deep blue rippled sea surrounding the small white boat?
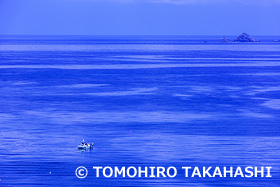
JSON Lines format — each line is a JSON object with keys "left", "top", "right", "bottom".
{"left": 0, "top": 36, "right": 280, "bottom": 187}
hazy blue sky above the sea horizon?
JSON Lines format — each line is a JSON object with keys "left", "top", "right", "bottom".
{"left": 0, "top": 0, "right": 280, "bottom": 35}
